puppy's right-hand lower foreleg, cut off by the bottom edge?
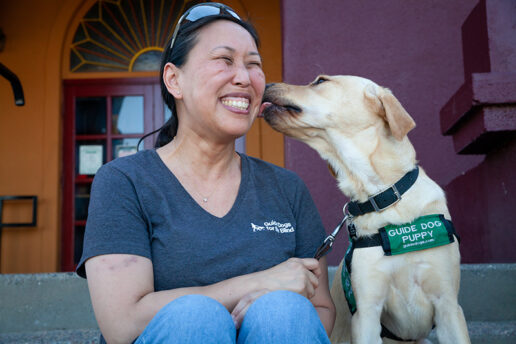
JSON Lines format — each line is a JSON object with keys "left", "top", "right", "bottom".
{"left": 435, "top": 298, "right": 470, "bottom": 344}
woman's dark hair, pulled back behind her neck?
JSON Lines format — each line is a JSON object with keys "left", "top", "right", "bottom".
{"left": 138, "top": 9, "right": 260, "bottom": 148}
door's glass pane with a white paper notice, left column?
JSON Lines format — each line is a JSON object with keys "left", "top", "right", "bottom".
{"left": 75, "top": 140, "right": 106, "bottom": 178}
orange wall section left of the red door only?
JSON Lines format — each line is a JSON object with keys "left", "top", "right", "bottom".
{"left": 0, "top": 0, "right": 80, "bottom": 273}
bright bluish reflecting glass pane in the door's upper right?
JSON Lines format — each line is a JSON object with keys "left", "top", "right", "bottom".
{"left": 111, "top": 96, "right": 143, "bottom": 134}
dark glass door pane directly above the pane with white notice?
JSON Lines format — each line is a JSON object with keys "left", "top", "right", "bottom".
{"left": 75, "top": 97, "right": 107, "bottom": 135}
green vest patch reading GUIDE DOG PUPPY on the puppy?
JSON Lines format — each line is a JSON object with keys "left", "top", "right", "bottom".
{"left": 379, "top": 215, "right": 456, "bottom": 256}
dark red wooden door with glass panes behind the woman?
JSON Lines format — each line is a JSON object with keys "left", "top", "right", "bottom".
{"left": 61, "top": 78, "right": 166, "bottom": 271}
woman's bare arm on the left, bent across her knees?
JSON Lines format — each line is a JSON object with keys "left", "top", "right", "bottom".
{"left": 86, "top": 254, "right": 318, "bottom": 343}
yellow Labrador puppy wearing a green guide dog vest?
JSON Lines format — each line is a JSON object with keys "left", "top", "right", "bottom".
{"left": 263, "top": 75, "right": 470, "bottom": 344}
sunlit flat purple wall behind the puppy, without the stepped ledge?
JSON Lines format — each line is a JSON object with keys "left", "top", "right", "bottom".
{"left": 282, "top": 0, "right": 483, "bottom": 265}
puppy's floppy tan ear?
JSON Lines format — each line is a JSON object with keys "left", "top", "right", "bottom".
{"left": 365, "top": 84, "right": 416, "bottom": 141}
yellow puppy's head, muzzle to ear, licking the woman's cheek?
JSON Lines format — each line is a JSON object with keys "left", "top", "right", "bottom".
{"left": 263, "top": 75, "right": 415, "bottom": 141}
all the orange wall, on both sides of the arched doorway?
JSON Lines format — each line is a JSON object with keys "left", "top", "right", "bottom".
{"left": 0, "top": 0, "right": 284, "bottom": 273}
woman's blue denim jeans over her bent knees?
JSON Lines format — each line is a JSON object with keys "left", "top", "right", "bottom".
{"left": 135, "top": 291, "right": 330, "bottom": 344}
